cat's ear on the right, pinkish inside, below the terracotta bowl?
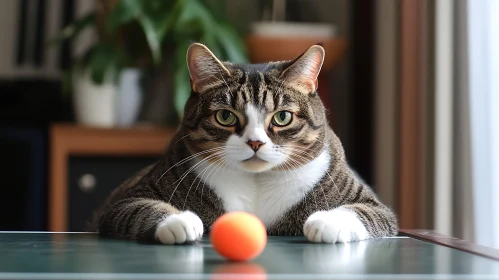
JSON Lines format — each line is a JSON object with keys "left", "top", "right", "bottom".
{"left": 281, "top": 45, "right": 325, "bottom": 94}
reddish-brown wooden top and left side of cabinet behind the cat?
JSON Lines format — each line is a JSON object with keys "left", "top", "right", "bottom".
{"left": 49, "top": 123, "right": 176, "bottom": 231}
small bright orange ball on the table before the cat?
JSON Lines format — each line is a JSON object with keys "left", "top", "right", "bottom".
{"left": 210, "top": 212, "right": 267, "bottom": 261}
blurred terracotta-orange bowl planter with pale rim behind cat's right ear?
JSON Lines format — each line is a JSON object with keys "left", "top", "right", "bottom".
{"left": 245, "top": 0, "right": 347, "bottom": 123}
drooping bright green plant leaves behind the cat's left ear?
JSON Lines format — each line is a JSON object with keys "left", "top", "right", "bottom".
{"left": 103, "top": 0, "right": 248, "bottom": 120}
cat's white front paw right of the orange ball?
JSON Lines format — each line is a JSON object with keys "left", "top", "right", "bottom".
{"left": 303, "top": 208, "right": 369, "bottom": 243}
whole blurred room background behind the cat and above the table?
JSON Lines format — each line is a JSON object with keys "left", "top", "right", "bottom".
{"left": 0, "top": 0, "right": 499, "bottom": 248}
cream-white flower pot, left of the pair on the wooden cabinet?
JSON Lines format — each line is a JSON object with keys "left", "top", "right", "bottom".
{"left": 73, "top": 72, "right": 117, "bottom": 127}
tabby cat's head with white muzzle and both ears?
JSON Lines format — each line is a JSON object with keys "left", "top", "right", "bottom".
{"left": 183, "top": 43, "right": 328, "bottom": 172}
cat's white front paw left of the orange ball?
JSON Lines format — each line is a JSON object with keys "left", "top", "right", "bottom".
{"left": 154, "top": 211, "right": 204, "bottom": 245}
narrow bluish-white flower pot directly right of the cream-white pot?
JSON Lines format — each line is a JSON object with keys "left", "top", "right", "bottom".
{"left": 116, "top": 68, "right": 142, "bottom": 126}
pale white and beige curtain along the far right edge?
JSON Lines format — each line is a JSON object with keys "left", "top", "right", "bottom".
{"left": 433, "top": 0, "right": 499, "bottom": 248}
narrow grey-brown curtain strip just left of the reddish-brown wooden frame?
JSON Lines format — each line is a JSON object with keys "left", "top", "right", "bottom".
{"left": 374, "top": 1, "right": 399, "bottom": 209}
